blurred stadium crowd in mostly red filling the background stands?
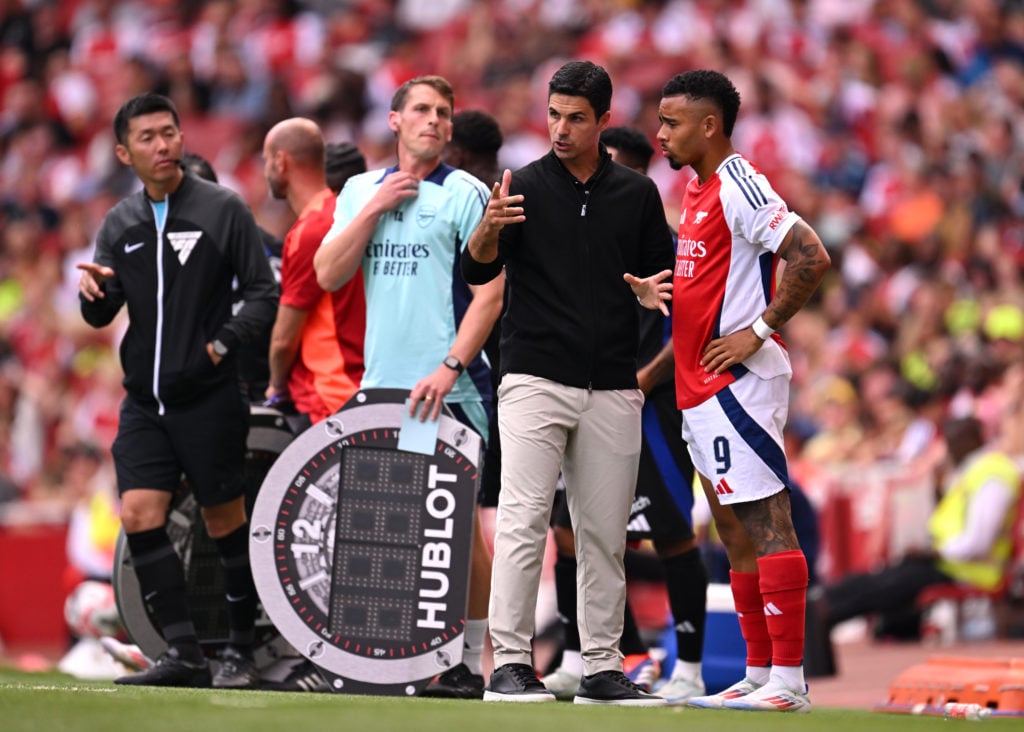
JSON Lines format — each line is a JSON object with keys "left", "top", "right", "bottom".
{"left": 0, "top": 0, "right": 1024, "bottom": 593}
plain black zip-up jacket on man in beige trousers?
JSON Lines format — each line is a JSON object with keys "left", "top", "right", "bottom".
{"left": 462, "top": 145, "right": 675, "bottom": 389}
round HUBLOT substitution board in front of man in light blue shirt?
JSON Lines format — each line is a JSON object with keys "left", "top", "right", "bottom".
{"left": 249, "top": 389, "right": 482, "bottom": 696}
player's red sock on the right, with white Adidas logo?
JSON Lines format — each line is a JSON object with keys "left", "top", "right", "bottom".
{"left": 758, "top": 549, "right": 807, "bottom": 665}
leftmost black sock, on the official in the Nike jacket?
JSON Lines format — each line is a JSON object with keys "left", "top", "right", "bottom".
{"left": 125, "top": 526, "right": 203, "bottom": 662}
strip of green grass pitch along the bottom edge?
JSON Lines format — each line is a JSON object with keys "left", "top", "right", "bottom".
{"left": 0, "top": 669, "right": 1024, "bottom": 732}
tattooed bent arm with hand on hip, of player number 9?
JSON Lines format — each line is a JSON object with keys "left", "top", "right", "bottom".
{"left": 700, "top": 221, "right": 831, "bottom": 374}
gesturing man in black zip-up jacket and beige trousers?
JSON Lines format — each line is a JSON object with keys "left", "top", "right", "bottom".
{"left": 462, "top": 61, "right": 673, "bottom": 705}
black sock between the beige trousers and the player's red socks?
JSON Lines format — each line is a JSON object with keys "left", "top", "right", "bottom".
{"left": 662, "top": 549, "right": 708, "bottom": 663}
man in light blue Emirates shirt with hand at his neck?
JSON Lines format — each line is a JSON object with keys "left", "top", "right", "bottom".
{"left": 313, "top": 76, "right": 504, "bottom": 698}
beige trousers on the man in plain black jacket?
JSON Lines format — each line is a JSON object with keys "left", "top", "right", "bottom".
{"left": 488, "top": 374, "right": 643, "bottom": 676}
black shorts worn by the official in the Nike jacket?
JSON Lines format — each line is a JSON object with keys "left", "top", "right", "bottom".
{"left": 111, "top": 382, "right": 249, "bottom": 507}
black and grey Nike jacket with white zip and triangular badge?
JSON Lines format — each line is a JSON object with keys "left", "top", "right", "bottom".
{"left": 79, "top": 173, "right": 278, "bottom": 413}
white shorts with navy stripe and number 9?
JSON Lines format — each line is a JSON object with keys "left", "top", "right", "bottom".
{"left": 683, "top": 373, "right": 790, "bottom": 505}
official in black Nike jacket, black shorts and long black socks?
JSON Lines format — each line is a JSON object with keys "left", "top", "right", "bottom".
{"left": 79, "top": 94, "right": 278, "bottom": 688}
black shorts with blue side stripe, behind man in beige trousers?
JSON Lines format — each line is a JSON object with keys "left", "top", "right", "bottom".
{"left": 551, "top": 387, "right": 693, "bottom": 542}
